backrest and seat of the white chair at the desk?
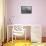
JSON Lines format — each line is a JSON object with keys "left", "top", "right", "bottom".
{"left": 12, "top": 25, "right": 24, "bottom": 36}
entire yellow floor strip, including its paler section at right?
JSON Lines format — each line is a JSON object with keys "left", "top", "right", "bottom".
{"left": 3, "top": 40, "right": 46, "bottom": 46}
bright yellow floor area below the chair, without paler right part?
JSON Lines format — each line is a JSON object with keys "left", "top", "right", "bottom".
{"left": 4, "top": 40, "right": 31, "bottom": 46}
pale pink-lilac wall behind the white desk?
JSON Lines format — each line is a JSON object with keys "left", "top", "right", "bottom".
{"left": 7, "top": 0, "right": 46, "bottom": 37}
